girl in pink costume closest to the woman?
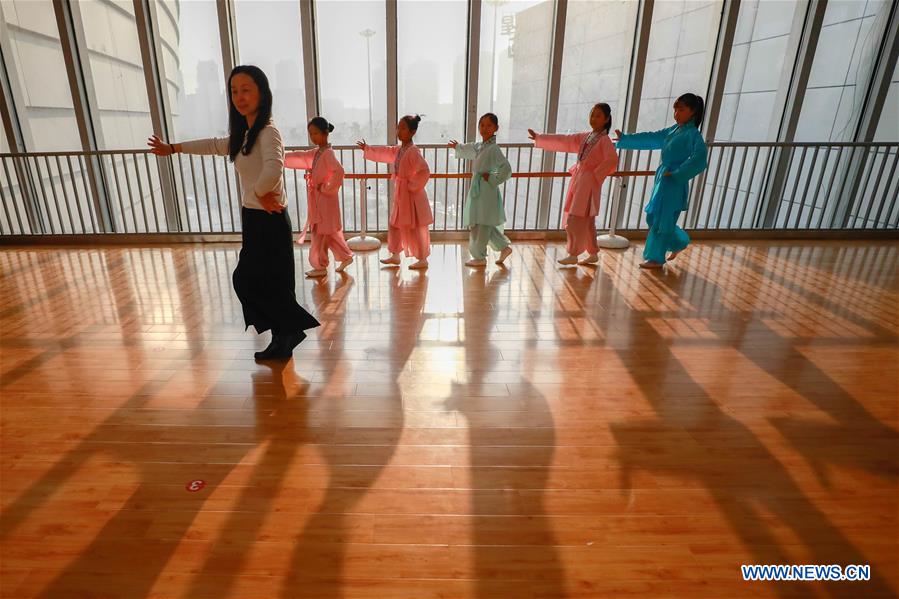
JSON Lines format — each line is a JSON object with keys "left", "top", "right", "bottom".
{"left": 284, "top": 116, "right": 353, "bottom": 277}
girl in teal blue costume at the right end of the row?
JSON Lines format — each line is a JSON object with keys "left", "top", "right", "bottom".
{"left": 615, "top": 94, "right": 708, "bottom": 268}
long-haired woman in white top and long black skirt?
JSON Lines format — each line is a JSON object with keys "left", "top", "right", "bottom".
{"left": 149, "top": 66, "right": 319, "bottom": 360}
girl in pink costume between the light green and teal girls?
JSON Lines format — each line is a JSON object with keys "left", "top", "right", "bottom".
{"left": 528, "top": 103, "right": 618, "bottom": 265}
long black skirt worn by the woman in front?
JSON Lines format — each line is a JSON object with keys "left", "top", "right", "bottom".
{"left": 232, "top": 208, "right": 320, "bottom": 334}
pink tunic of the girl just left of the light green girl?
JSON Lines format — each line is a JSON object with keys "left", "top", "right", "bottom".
{"left": 364, "top": 145, "right": 434, "bottom": 229}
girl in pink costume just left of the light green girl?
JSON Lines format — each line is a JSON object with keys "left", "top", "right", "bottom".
{"left": 357, "top": 115, "right": 434, "bottom": 269}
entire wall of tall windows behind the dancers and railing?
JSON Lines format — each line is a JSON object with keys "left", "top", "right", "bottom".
{"left": 0, "top": 0, "right": 899, "bottom": 233}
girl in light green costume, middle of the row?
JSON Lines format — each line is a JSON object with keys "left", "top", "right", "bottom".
{"left": 448, "top": 112, "right": 512, "bottom": 267}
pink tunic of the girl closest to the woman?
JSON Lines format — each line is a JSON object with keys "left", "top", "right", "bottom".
{"left": 284, "top": 148, "right": 343, "bottom": 243}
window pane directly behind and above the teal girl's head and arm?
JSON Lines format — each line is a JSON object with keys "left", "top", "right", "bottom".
{"left": 638, "top": 0, "right": 722, "bottom": 131}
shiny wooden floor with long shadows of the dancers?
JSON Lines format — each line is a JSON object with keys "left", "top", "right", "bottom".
{"left": 0, "top": 242, "right": 899, "bottom": 599}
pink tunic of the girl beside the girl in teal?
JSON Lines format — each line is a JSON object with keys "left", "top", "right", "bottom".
{"left": 534, "top": 131, "right": 618, "bottom": 224}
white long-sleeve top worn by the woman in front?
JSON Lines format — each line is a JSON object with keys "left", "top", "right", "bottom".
{"left": 181, "top": 122, "right": 287, "bottom": 210}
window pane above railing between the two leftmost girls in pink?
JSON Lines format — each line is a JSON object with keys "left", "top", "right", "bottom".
{"left": 315, "top": 0, "right": 386, "bottom": 144}
